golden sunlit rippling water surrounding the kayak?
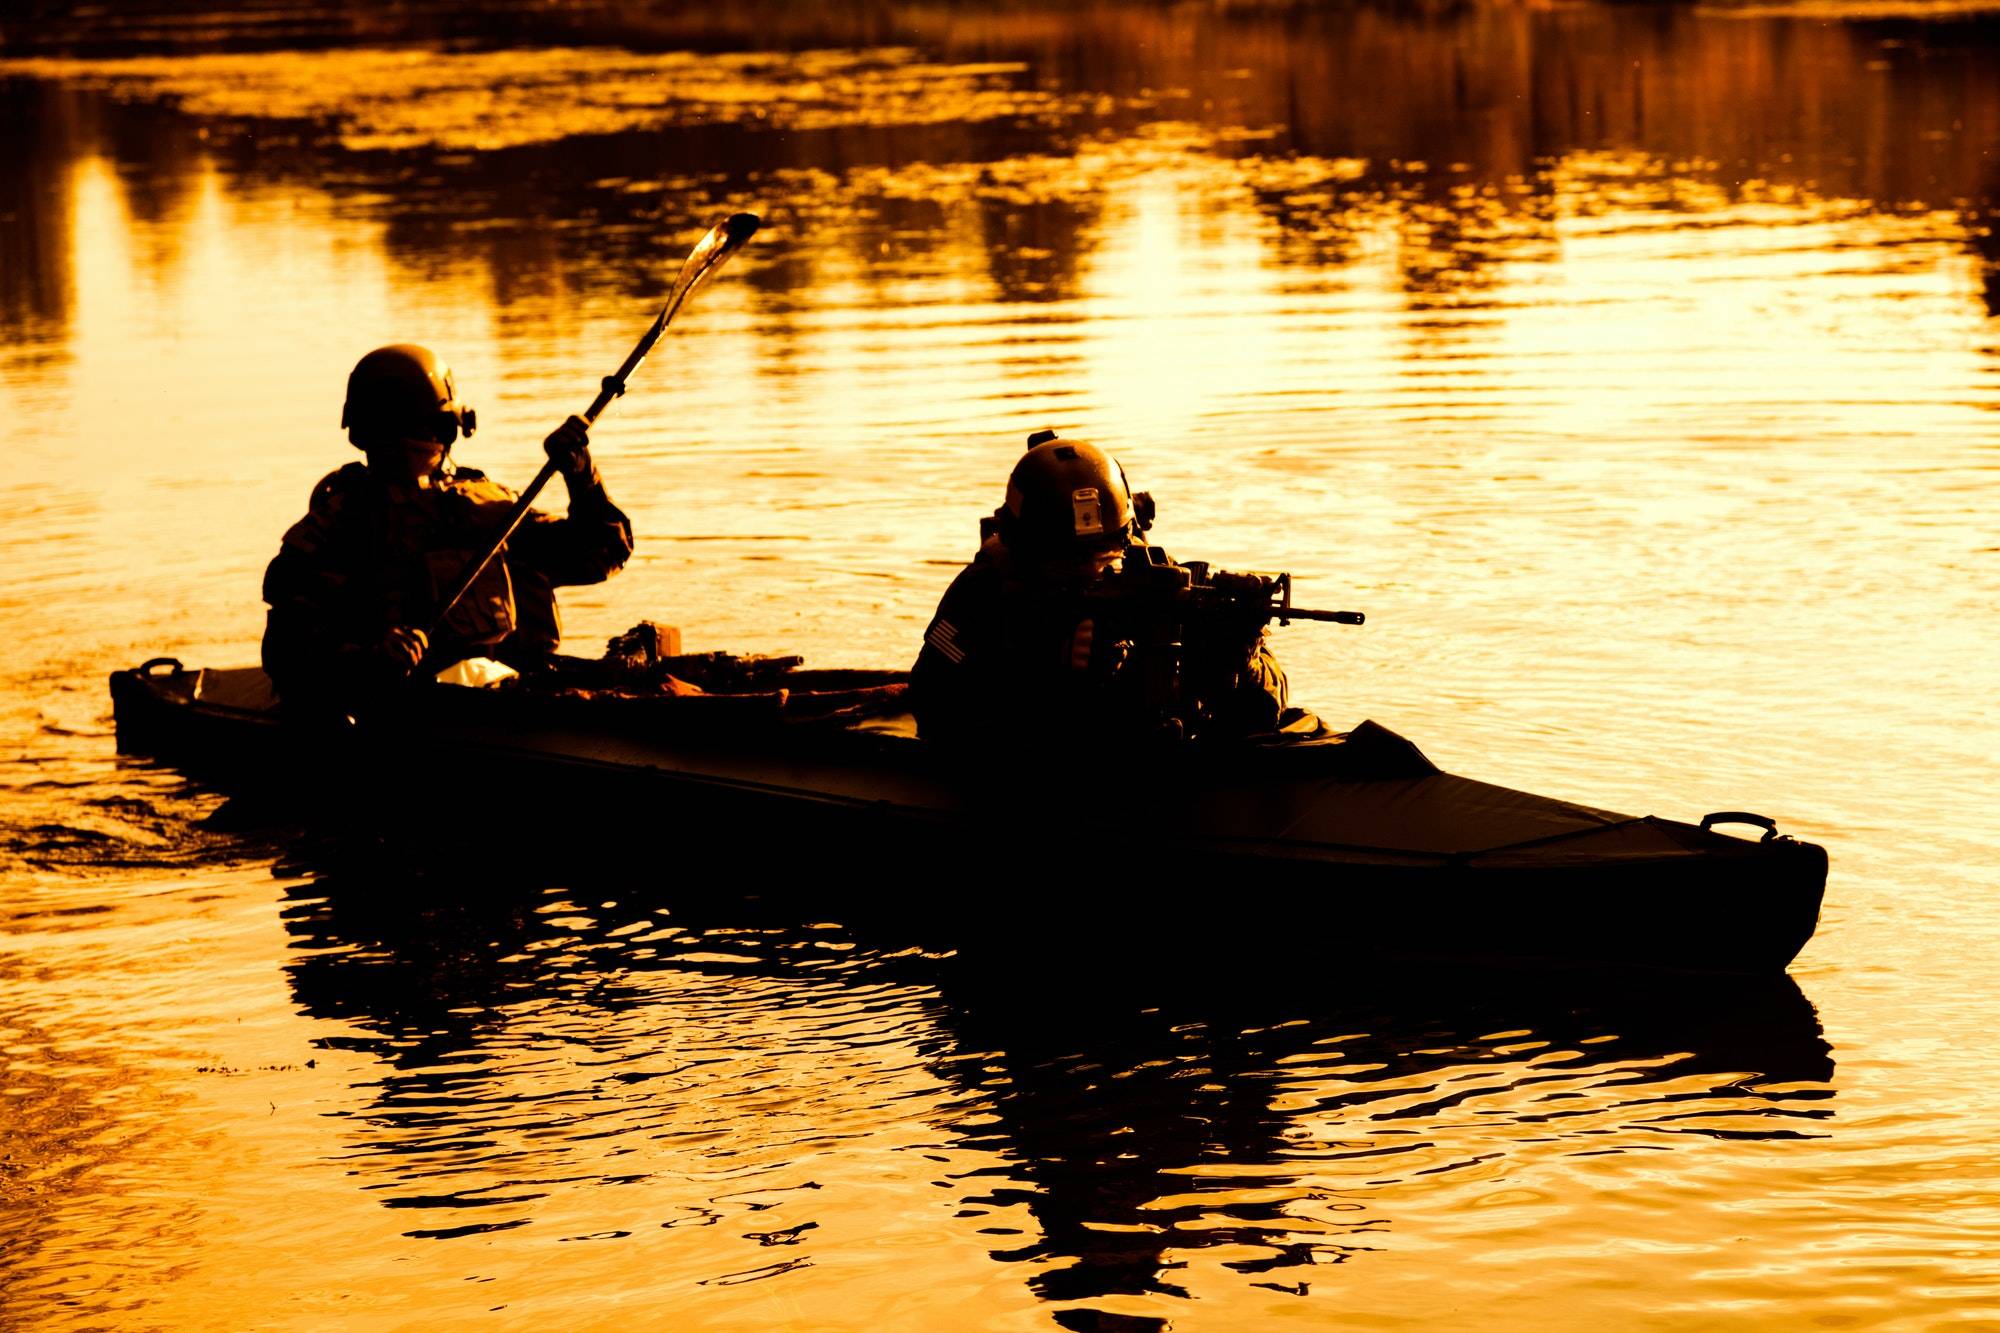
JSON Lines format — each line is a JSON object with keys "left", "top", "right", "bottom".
{"left": 0, "top": 4, "right": 2000, "bottom": 1329}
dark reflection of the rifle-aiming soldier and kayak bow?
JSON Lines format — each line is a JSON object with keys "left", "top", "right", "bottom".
{"left": 946, "top": 959, "right": 1832, "bottom": 1301}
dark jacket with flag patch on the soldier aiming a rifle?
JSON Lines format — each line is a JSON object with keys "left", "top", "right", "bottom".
{"left": 910, "top": 542, "right": 1318, "bottom": 748}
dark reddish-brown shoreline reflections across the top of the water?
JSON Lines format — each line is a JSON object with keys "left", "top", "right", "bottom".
{"left": 0, "top": 0, "right": 2000, "bottom": 378}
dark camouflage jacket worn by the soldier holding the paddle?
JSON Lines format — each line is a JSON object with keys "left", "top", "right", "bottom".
{"left": 264, "top": 462, "right": 632, "bottom": 701}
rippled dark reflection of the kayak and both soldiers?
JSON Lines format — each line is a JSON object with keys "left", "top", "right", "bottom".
{"left": 266, "top": 856, "right": 1834, "bottom": 1327}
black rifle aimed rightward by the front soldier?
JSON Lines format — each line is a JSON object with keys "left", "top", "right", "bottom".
{"left": 1078, "top": 542, "right": 1366, "bottom": 737}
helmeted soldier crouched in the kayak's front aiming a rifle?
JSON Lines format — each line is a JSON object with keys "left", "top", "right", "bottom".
{"left": 910, "top": 430, "right": 1320, "bottom": 755}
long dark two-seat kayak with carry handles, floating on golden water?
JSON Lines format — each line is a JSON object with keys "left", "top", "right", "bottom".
{"left": 110, "top": 654, "right": 1828, "bottom": 975}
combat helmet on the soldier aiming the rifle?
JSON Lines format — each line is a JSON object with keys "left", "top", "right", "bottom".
{"left": 992, "top": 430, "right": 1152, "bottom": 556}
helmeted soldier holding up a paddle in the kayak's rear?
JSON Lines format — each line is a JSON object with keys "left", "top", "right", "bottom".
{"left": 264, "top": 344, "right": 632, "bottom": 711}
